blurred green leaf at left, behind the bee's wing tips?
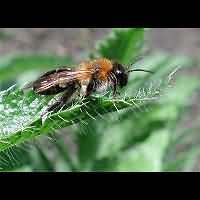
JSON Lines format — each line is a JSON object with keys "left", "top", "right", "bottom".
{"left": 0, "top": 54, "right": 72, "bottom": 87}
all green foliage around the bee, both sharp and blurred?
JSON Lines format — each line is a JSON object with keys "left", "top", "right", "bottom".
{"left": 0, "top": 28, "right": 200, "bottom": 171}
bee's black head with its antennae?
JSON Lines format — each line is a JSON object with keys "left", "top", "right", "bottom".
{"left": 112, "top": 62, "right": 153, "bottom": 88}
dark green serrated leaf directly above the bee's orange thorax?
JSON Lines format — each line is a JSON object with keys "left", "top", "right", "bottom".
{"left": 93, "top": 28, "right": 144, "bottom": 64}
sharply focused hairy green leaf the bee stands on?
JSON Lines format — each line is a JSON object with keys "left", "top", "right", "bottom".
{"left": 0, "top": 84, "right": 156, "bottom": 151}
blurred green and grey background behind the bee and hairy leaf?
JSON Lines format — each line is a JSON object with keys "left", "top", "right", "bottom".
{"left": 0, "top": 28, "right": 200, "bottom": 172}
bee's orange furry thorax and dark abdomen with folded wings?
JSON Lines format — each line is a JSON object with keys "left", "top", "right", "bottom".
{"left": 33, "top": 59, "right": 123, "bottom": 96}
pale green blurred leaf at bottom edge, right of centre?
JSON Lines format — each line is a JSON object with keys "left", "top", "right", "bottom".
{"left": 94, "top": 130, "right": 169, "bottom": 172}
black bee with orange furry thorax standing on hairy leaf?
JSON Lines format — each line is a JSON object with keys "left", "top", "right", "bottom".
{"left": 25, "top": 58, "right": 152, "bottom": 112}
